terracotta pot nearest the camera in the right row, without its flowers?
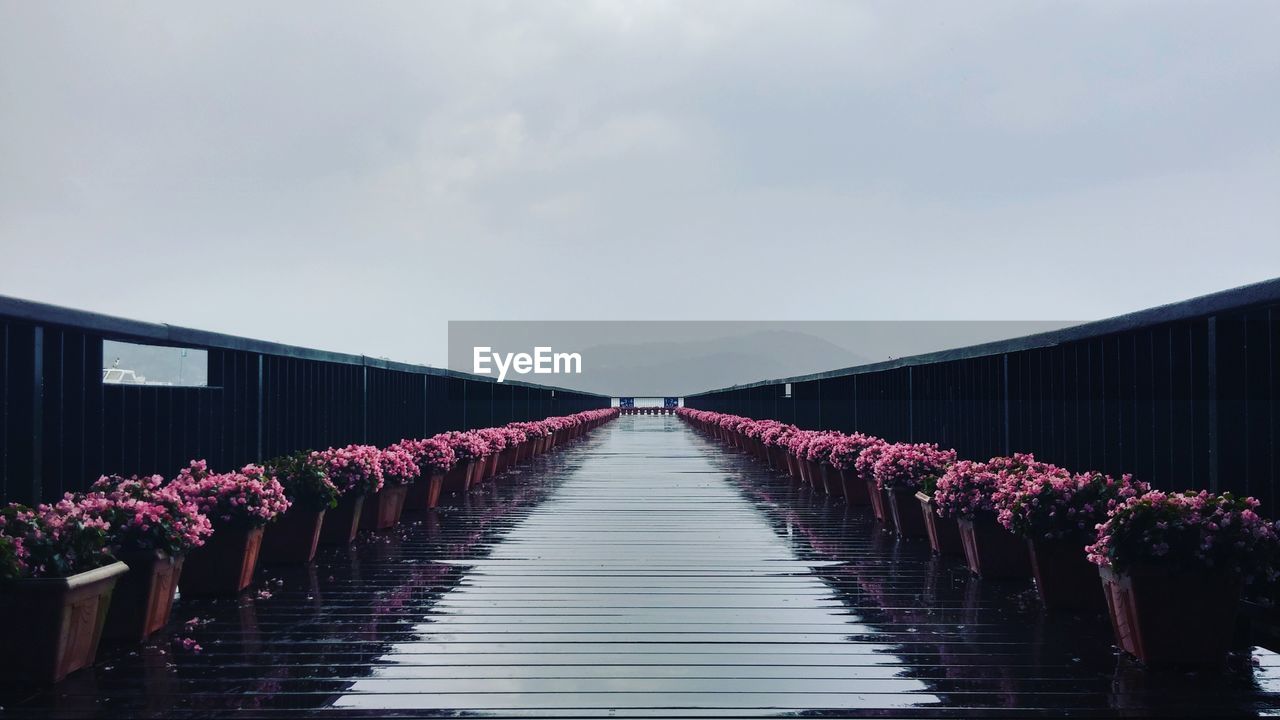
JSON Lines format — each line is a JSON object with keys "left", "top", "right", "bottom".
{"left": 1098, "top": 568, "right": 1242, "bottom": 665}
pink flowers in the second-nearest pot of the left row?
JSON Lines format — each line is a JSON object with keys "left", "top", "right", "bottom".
{"left": 79, "top": 475, "right": 214, "bottom": 557}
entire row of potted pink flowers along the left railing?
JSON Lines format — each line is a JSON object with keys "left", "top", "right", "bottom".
{"left": 0, "top": 410, "right": 617, "bottom": 682}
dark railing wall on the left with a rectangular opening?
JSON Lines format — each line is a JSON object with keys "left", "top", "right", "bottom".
{"left": 0, "top": 296, "right": 609, "bottom": 502}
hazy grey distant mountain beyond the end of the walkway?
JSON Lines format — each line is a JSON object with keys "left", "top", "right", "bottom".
{"left": 556, "top": 331, "right": 868, "bottom": 397}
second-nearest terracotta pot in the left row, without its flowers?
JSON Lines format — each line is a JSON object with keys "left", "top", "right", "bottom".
{"left": 102, "top": 550, "right": 184, "bottom": 642}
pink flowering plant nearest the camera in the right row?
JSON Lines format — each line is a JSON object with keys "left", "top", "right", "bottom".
{"left": 1084, "top": 491, "right": 1280, "bottom": 583}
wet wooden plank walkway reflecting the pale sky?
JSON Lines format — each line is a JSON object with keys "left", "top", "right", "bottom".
{"left": 0, "top": 416, "right": 1280, "bottom": 719}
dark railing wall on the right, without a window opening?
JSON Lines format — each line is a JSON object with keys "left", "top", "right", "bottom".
{"left": 685, "top": 279, "right": 1280, "bottom": 515}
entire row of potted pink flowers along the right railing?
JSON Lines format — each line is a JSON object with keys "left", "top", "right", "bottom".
{"left": 680, "top": 409, "right": 1280, "bottom": 664}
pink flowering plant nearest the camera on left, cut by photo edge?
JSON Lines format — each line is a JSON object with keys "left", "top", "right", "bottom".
{"left": 0, "top": 493, "right": 115, "bottom": 579}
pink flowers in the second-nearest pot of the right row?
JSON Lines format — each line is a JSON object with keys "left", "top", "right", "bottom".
{"left": 995, "top": 464, "right": 1151, "bottom": 544}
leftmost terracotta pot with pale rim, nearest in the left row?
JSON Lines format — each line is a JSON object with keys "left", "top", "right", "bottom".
{"left": 0, "top": 562, "right": 129, "bottom": 683}
